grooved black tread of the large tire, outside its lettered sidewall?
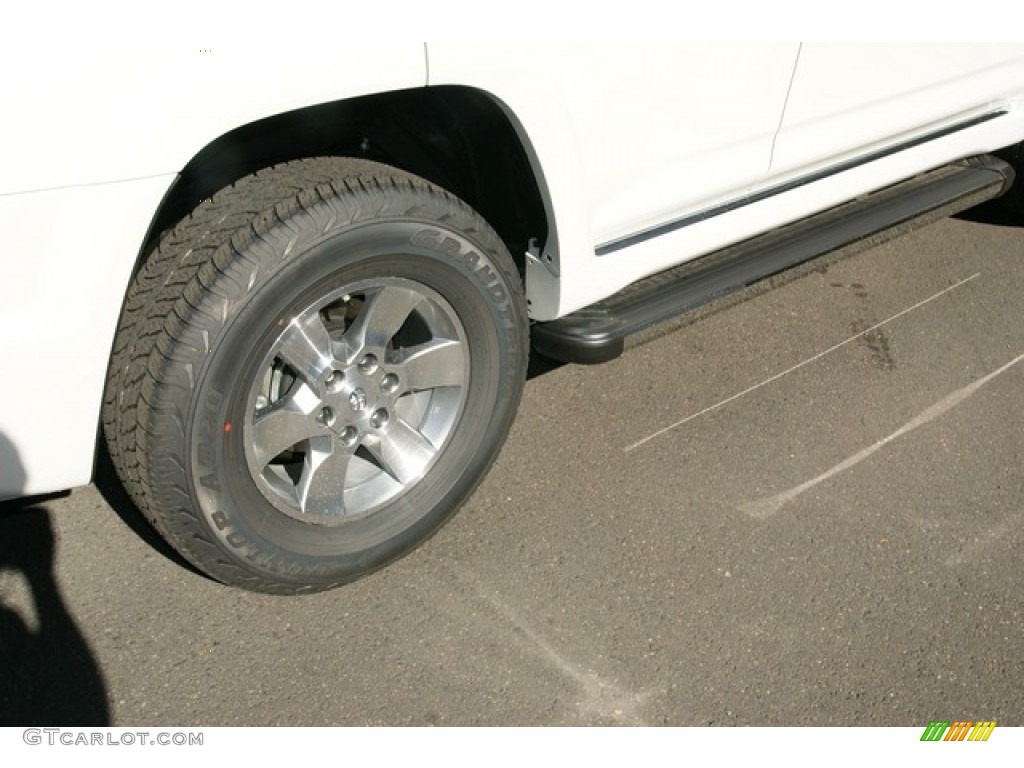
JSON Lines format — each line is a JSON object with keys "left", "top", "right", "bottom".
{"left": 101, "top": 157, "right": 526, "bottom": 594}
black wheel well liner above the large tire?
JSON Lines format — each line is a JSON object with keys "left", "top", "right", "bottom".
{"left": 142, "top": 86, "right": 549, "bottom": 272}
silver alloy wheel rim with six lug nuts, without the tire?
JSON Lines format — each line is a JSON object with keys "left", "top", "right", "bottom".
{"left": 246, "top": 275, "right": 470, "bottom": 524}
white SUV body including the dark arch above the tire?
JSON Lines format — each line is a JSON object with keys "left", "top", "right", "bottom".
{"left": 0, "top": 44, "right": 1024, "bottom": 588}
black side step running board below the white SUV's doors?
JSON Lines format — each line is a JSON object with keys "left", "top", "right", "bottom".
{"left": 532, "top": 155, "right": 1014, "bottom": 364}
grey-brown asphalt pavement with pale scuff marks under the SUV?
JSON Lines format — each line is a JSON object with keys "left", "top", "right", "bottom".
{"left": 0, "top": 205, "right": 1024, "bottom": 728}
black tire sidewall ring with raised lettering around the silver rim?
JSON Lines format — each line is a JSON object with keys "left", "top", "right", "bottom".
{"left": 185, "top": 214, "right": 525, "bottom": 585}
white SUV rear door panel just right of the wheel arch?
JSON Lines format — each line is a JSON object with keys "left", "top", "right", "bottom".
{"left": 428, "top": 43, "right": 798, "bottom": 246}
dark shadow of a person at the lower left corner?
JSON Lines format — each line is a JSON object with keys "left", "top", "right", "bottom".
{"left": 0, "top": 434, "right": 111, "bottom": 726}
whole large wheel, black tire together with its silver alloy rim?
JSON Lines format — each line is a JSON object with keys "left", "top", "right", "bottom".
{"left": 103, "top": 158, "right": 528, "bottom": 594}
